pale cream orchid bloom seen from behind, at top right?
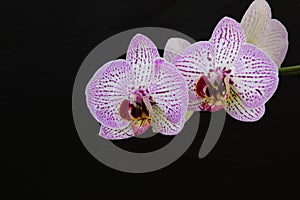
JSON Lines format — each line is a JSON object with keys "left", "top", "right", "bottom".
{"left": 241, "top": 0, "right": 288, "bottom": 67}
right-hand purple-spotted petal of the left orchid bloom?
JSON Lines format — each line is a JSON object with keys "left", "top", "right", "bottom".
{"left": 148, "top": 59, "right": 188, "bottom": 123}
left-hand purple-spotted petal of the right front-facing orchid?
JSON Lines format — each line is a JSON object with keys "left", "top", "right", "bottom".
{"left": 173, "top": 41, "right": 214, "bottom": 111}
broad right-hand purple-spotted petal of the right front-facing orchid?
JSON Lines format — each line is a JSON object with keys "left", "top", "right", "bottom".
{"left": 231, "top": 44, "right": 278, "bottom": 108}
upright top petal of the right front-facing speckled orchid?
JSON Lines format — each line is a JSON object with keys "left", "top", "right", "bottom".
{"left": 210, "top": 17, "right": 246, "bottom": 71}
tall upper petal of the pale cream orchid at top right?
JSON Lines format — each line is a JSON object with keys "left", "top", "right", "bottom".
{"left": 241, "top": 0, "right": 271, "bottom": 45}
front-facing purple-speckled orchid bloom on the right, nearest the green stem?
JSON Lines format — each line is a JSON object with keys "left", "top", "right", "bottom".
{"left": 172, "top": 17, "right": 278, "bottom": 121}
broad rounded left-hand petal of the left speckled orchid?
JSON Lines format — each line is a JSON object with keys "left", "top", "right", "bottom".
{"left": 86, "top": 60, "right": 133, "bottom": 128}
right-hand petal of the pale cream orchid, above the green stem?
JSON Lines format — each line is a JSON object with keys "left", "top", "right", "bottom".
{"left": 256, "top": 19, "right": 289, "bottom": 67}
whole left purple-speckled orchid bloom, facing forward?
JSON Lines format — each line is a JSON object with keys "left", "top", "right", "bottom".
{"left": 86, "top": 34, "right": 188, "bottom": 140}
